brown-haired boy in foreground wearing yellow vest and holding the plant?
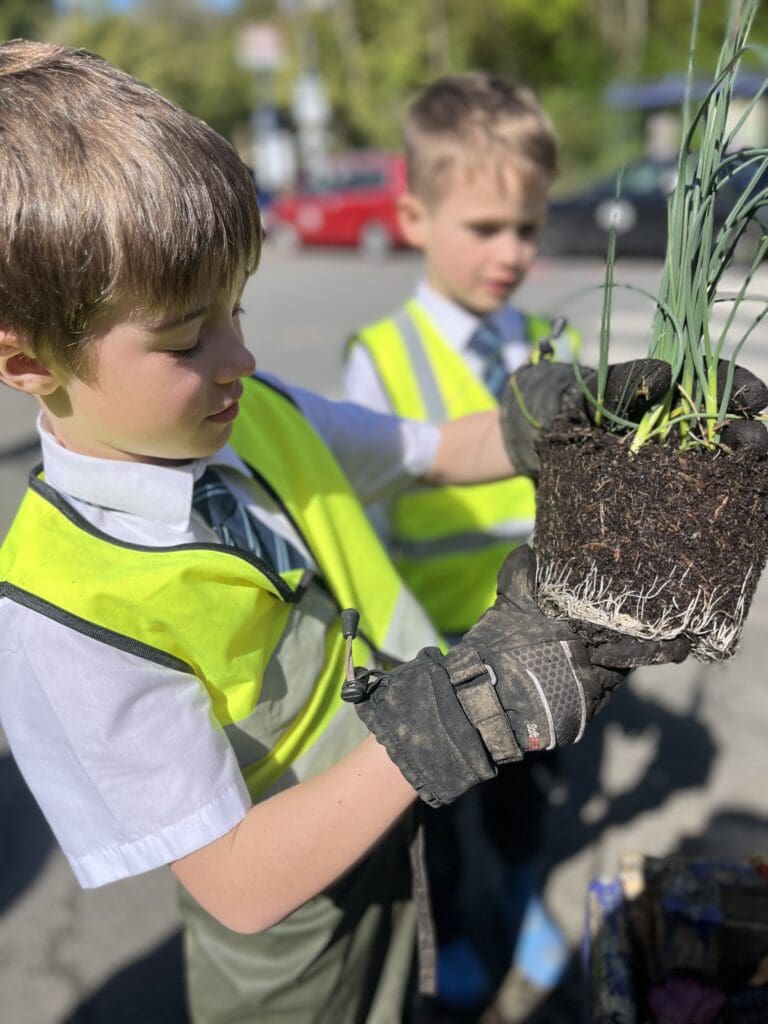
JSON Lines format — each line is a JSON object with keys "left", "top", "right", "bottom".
{"left": 0, "top": 41, "right": 685, "bottom": 1024}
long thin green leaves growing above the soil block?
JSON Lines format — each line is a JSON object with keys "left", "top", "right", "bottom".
{"left": 589, "top": 0, "right": 768, "bottom": 450}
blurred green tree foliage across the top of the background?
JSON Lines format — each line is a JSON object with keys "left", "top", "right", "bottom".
{"left": 40, "top": 0, "right": 768, "bottom": 182}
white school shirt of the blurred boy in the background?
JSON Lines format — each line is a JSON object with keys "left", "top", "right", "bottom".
{"left": 344, "top": 281, "right": 530, "bottom": 413}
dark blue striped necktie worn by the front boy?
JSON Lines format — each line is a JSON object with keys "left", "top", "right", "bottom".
{"left": 193, "top": 467, "right": 307, "bottom": 572}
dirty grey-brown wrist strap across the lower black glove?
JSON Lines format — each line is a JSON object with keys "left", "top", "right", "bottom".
{"left": 442, "top": 643, "right": 523, "bottom": 764}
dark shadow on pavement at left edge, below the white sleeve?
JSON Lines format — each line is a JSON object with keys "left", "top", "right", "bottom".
{"left": 0, "top": 754, "right": 54, "bottom": 913}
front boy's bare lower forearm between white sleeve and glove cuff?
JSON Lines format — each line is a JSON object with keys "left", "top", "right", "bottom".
{"left": 172, "top": 737, "right": 416, "bottom": 933}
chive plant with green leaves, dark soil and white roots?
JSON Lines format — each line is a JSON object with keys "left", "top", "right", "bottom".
{"left": 535, "top": 0, "right": 768, "bottom": 662}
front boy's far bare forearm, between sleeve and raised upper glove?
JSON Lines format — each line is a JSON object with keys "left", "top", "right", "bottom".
{"left": 423, "top": 410, "right": 515, "bottom": 484}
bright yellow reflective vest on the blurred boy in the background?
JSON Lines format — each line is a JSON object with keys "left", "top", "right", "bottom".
{"left": 347, "top": 300, "right": 580, "bottom": 635}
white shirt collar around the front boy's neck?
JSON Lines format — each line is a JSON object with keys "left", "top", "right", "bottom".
{"left": 38, "top": 414, "right": 244, "bottom": 529}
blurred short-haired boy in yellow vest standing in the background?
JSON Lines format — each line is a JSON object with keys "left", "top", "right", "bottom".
{"left": 345, "top": 73, "right": 578, "bottom": 637}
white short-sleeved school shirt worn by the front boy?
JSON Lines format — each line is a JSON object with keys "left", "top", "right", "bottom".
{"left": 0, "top": 376, "right": 439, "bottom": 888}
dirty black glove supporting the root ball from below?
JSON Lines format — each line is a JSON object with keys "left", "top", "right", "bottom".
{"left": 344, "top": 546, "right": 688, "bottom": 807}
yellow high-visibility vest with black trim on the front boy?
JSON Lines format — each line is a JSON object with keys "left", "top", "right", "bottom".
{"left": 0, "top": 379, "right": 437, "bottom": 798}
